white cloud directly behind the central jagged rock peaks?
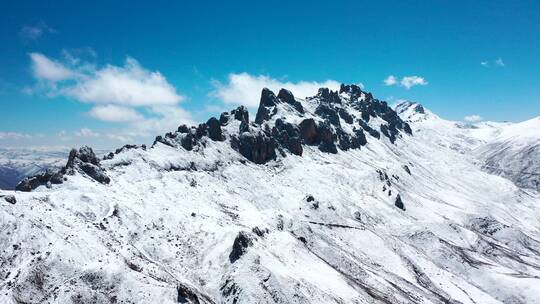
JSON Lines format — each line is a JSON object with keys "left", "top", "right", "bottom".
{"left": 211, "top": 73, "right": 340, "bottom": 107}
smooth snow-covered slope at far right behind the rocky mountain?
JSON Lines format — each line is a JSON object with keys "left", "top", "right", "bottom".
{"left": 396, "top": 102, "right": 540, "bottom": 190}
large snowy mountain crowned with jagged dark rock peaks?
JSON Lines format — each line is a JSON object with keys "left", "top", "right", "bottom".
{"left": 0, "top": 85, "right": 540, "bottom": 303}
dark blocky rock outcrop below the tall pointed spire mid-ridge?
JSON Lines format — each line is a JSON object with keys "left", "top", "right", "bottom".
{"left": 231, "top": 131, "right": 276, "bottom": 164}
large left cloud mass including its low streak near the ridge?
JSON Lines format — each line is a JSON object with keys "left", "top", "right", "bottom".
{"left": 26, "top": 49, "right": 193, "bottom": 140}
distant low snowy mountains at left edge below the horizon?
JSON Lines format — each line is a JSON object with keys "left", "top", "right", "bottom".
{"left": 0, "top": 148, "right": 69, "bottom": 190}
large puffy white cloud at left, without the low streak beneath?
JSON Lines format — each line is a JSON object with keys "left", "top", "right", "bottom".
{"left": 30, "top": 53, "right": 184, "bottom": 106}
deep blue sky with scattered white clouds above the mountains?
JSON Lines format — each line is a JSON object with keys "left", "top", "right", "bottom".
{"left": 0, "top": 1, "right": 540, "bottom": 148}
